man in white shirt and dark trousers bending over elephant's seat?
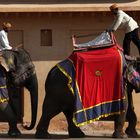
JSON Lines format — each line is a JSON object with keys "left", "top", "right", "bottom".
{"left": 108, "top": 4, "right": 140, "bottom": 55}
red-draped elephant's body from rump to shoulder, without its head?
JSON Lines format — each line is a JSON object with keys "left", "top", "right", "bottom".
{"left": 35, "top": 32, "right": 127, "bottom": 138}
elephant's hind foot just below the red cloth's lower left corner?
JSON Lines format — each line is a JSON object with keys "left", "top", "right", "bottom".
{"left": 68, "top": 127, "right": 85, "bottom": 138}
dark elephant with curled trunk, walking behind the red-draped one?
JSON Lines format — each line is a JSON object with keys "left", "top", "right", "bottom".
{"left": 0, "top": 48, "right": 38, "bottom": 137}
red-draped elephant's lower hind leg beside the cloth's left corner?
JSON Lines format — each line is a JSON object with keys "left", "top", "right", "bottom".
{"left": 63, "top": 110, "right": 85, "bottom": 138}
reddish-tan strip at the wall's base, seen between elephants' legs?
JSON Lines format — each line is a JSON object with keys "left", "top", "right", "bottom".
{"left": 0, "top": 118, "right": 140, "bottom": 135}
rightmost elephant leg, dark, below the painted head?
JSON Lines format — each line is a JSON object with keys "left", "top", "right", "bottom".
{"left": 125, "top": 84, "right": 138, "bottom": 138}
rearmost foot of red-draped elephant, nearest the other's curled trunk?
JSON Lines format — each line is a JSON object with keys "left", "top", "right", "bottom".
{"left": 35, "top": 129, "right": 51, "bottom": 139}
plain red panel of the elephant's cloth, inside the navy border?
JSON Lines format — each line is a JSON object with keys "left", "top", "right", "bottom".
{"left": 70, "top": 47, "right": 122, "bottom": 108}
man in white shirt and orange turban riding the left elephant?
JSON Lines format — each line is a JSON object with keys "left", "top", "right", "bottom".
{"left": 0, "top": 22, "right": 12, "bottom": 51}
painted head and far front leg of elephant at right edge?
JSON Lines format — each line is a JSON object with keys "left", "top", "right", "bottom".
{"left": 125, "top": 55, "right": 140, "bottom": 138}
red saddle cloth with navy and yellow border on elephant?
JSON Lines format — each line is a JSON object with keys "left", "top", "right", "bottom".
{"left": 57, "top": 45, "right": 125, "bottom": 126}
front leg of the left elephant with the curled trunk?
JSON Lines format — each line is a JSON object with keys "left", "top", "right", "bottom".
{"left": 0, "top": 102, "right": 21, "bottom": 137}
